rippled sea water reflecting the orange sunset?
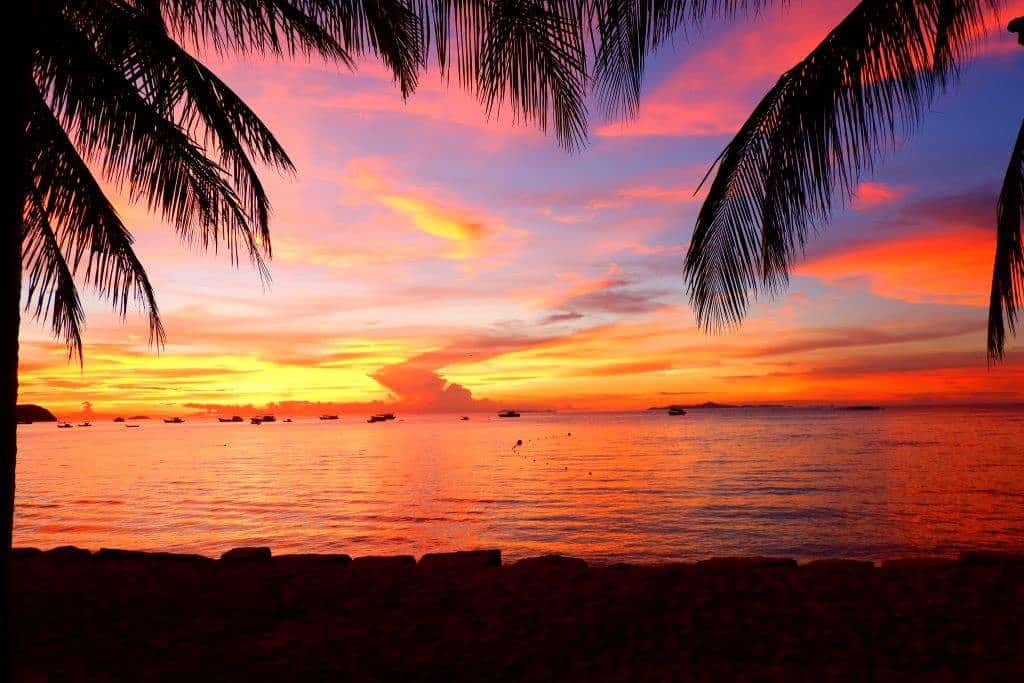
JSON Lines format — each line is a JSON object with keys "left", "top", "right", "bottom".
{"left": 14, "top": 408, "right": 1024, "bottom": 561}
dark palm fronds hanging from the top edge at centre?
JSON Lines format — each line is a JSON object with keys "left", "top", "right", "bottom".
{"left": 408, "top": 0, "right": 770, "bottom": 150}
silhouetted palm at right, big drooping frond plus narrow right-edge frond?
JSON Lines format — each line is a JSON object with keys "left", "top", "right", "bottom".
{"left": 684, "top": 0, "right": 1024, "bottom": 362}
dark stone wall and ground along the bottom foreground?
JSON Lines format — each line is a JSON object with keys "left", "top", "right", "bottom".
{"left": 12, "top": 549, "right": 1024, "bottom": 681}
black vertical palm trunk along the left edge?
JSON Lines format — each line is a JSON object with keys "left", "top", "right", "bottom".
{"left": 0, "top": 30, "right": 35, "bottom": 680}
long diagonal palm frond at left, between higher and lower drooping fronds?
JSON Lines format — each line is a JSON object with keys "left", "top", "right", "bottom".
{"left": 37, "top": 8, "right": 268, "bottom": 278}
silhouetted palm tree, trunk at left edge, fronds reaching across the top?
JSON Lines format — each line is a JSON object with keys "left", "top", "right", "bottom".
{"left": 0, "top": 0, "right": 774, "bottom": 663}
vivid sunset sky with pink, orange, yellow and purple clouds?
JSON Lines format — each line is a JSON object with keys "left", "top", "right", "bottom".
{"left": 20, "top": 0, "right": 1024, "bottom": 417}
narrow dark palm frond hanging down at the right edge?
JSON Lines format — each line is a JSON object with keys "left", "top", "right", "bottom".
{"left": 988, "top": 121, "right": 1024, "bottom": 362}
